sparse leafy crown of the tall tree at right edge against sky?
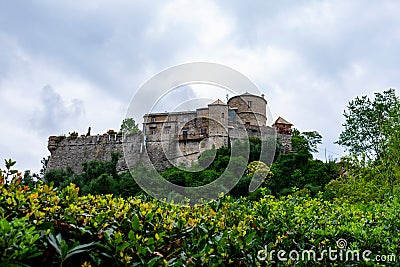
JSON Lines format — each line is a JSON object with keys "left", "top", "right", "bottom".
{"left": 336, "top": 89, "right": 400, "bottom": 160}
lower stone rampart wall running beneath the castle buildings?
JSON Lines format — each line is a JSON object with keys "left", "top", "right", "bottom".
{"left": 47, "top": 126, "right": 290, "bottom": 173}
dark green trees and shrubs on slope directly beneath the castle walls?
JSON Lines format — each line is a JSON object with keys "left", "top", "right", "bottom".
{"left": 44, "top": 129, "right": 339, "bottom": 198}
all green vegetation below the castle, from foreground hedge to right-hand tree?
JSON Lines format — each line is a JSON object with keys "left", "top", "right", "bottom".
{"left": 0, "top": 90, "right": 400, "bottom": 266}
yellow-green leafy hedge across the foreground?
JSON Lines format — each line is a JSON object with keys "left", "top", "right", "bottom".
{"left": 0, "top": 170, "right": 400, "bottom": 266}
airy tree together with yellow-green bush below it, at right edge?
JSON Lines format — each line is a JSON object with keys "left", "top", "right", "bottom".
{"left": 326, "top": 89, "right": 400, "bottom": 203}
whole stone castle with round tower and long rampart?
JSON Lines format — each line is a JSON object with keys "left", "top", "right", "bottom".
{"left": 48, "top": 93, "right": 292, "bottom": 172}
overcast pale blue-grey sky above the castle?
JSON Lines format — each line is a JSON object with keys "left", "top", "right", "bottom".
{"left": 0, "top": 0, "right": 400, "bottom": 171}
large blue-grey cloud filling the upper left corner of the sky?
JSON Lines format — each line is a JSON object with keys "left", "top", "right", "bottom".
{"left": 0, "top": 1, "right": 169, "bottom": 99}
